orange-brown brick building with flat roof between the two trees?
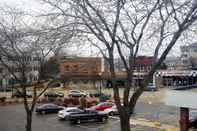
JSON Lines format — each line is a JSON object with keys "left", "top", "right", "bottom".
{"left": 59, "top": 57, "right": 103, "bottom": 87}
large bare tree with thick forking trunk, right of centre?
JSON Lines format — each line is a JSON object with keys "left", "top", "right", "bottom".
{"left": 40, "top": 0, "right": 197, "bottom": 131}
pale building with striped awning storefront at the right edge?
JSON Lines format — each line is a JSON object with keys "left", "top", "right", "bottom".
{"left": 154, "top": 42, "right": 197, "bottom": 88}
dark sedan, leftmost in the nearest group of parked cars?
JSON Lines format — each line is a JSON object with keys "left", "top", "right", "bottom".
{"left": 36, "top": 104, "right": 65, "bottom": 114}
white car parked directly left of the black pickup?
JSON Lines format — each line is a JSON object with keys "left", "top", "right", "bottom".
{"left": 58, "top": 107, "right": 83, "bottom": 120}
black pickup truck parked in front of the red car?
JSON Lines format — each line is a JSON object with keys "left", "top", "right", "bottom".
{"left": 69, "top": 110, "right": 108, "bottom": 124}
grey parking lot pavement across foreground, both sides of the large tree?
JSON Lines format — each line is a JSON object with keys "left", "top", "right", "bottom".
{"left": 0, "top": 103, "right": 182, "bottom": 131}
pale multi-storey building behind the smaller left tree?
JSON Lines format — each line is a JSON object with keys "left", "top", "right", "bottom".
{"left": 0, "top": 56, "right": 40, "bottom": 88}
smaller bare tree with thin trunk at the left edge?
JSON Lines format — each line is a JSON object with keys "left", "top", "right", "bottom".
{"left": 0, "top": 8, "right": 75, "bottom": 131}
